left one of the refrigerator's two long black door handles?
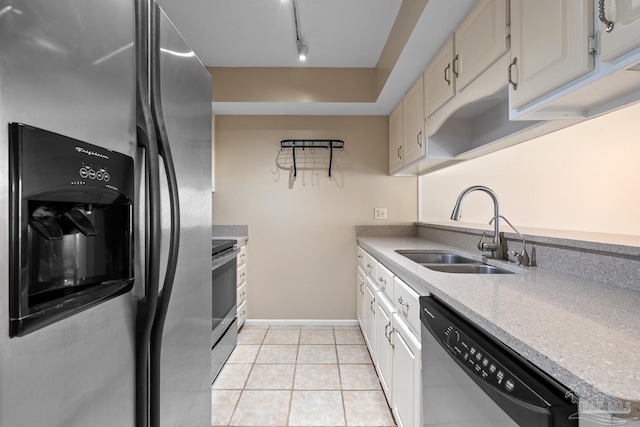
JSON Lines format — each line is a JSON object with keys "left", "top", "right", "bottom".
{"left": 135, "top": 0, "right": 161, "bottom": 427}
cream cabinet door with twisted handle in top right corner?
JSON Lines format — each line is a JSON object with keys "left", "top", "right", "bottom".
{"left": 598, "top": 0, "right": 640, "bottom": 61}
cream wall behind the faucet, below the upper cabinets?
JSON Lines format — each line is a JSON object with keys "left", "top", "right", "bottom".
{"left": 420, "top": 100, "right": 640, "bottom": 244}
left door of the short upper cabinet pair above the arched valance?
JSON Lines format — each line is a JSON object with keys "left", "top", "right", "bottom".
{"left": 424, "top": 36, "right": 456, "bottom": 117}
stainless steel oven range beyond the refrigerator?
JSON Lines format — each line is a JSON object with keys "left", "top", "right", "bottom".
{"left": 211, "top": 239, "right": 240, "bottom": 382}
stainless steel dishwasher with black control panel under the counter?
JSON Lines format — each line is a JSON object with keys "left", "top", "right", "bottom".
{"left": 420, "top": 296, "right": 578, "bottom": 427}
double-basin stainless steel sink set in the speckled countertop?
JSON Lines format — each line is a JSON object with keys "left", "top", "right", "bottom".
{"left": 396, "top": 250, "right": 513, "bottom": 274}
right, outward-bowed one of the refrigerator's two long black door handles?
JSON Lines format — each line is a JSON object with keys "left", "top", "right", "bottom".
{"left": 149, "top": 2, "right": 180, "bottom": 427}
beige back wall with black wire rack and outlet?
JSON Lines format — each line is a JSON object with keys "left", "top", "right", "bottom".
{"left": 213, "top": 116, "right": 417, "bottom": 319}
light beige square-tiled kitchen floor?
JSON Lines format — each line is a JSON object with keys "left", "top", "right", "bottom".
{"left": 211, "top": 326, "right": 395, "bottom": 427}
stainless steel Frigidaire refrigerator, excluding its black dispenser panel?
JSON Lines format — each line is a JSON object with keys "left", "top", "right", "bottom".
{"left": 0, "top": 0, "right": 211, "bottom": 427}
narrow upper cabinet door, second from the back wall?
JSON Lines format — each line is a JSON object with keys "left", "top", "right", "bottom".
{"left": 402, "top": 76, "right": 426, "bottom": 165}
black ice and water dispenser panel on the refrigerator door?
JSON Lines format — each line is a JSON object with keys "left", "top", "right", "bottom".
{"left": 9, "top": 123, "right": 134, "bottom": 337}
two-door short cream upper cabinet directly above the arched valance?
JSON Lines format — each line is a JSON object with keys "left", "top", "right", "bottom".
{"left": 424, "top": 0, "right": 509, "bottom": 117}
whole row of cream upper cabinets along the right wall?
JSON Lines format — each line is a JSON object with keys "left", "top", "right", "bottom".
{"left": 390, "top": 0, "right": 640, "bottom": 175}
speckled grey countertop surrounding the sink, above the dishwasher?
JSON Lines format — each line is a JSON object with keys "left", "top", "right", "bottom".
{"left": 357, "top": 237, "right": 640, "bottom": 417}
